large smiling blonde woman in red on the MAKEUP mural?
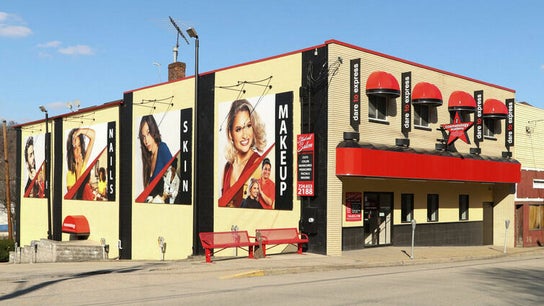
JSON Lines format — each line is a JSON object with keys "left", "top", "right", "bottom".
{"left": 220, "top": 99, "right": 266, "bottom": 207}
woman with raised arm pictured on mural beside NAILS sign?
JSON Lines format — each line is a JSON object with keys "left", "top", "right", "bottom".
{"left": 66, "top": 128, "right": 95, "bottom": 200}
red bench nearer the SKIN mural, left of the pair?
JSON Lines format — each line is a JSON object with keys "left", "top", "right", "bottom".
{"left": 198, "top": 231, "right": 259, "bottom": 262}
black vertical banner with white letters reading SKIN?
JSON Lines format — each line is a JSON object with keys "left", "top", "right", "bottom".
{"left": 178, "top": 108, "right": 193, "bottom": 204}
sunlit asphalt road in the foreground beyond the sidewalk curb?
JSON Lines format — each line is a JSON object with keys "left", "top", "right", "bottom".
{"left": 0, "top": 255, "right": 544, "bottom": 305}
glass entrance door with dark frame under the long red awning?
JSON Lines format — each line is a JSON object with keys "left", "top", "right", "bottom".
{"left": 363, "top": 192, "right": 393, "bottom": 246}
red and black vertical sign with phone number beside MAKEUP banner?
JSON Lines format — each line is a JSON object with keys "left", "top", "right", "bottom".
{"left": 297, "top": 134, "right": 315, "bottom": 196}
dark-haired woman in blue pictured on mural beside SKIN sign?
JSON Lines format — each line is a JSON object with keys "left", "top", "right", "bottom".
{"left": 138, "top": 115, "right": 172, "bottom": 188}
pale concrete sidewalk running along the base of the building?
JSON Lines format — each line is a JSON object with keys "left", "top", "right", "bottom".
{"left": 0, "top": 246, "right": 544, "bottom": 282}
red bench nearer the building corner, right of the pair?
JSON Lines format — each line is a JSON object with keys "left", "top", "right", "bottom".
{"left": 255, "top": 227, "right": 309, "bottom": 257}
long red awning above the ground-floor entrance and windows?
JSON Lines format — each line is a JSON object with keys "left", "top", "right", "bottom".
{"left": 336, "top": 147, "right": 521, "bottom": 183}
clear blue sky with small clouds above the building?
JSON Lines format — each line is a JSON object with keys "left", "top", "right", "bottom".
{"left": 0, "top": 0, "right": 544, "bottom": 123}
